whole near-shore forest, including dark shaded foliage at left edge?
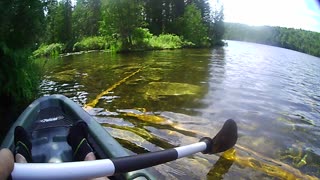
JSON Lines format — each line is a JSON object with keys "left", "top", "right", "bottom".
{"left": 0, "top": 0, "right": 224, "bottom": 135}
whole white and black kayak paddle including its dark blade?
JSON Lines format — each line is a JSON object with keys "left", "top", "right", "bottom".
{"left": 12, "top": 119, "right": 238, "bottom": 179}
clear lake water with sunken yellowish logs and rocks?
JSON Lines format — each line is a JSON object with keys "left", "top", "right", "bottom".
{"left": 41, "top": 41, "right": 320, "bottom": 179}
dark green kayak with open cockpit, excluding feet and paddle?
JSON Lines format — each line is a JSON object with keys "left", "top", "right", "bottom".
{"left": 1, "top": 95, "right": 156, "bottom": 179}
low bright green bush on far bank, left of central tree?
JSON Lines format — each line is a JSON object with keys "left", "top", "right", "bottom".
{"left": 73, "top": 36, "right": 106, "bottom": 51}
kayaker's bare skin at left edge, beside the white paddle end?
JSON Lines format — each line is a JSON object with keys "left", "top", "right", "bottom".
{"left": 0, "top": 149, "right": 14, "bottom": 179}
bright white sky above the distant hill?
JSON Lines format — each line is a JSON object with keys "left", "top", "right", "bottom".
{"left": 216, "top": 0, "right": 320, "bottom": 32}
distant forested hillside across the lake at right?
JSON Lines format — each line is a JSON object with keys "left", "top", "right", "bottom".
{"left": 224, "top": 23, "right": 320, "bottom": 57}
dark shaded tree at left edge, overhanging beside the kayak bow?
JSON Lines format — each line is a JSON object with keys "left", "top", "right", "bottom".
{"left": 0, "top": 0, "right": 44, "bottom": 137}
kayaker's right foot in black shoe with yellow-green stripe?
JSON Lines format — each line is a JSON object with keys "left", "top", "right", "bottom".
{"left": 67, "top": 121, "right": 93, "bottom": 161}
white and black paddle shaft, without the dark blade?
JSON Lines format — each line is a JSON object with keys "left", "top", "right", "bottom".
{"left": 12, "top": 141, "right": 208, "bottom": 179}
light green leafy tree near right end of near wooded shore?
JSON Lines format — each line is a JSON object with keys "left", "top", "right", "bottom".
{"left": 182, "top": 4, "right": 209, "bottom": 46}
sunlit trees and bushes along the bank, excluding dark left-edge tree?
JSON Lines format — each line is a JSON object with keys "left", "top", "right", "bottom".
{"left": 35, "top": 0, "right": 224, "bottom": 55}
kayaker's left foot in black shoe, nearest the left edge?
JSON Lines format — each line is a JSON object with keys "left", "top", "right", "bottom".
{"left": 14, "top": 126, "right": 32, "bottom": 162}
